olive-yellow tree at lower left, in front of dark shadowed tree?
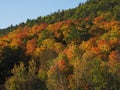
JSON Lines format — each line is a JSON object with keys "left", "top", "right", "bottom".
{"left": 5, "top": 61, "right": 47, "bottom": 90}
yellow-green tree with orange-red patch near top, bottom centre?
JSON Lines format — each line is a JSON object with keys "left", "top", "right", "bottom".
{"left": 47, "top": 55, "right": 73, "bottom": 90}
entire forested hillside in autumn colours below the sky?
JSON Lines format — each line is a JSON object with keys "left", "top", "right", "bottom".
{"left": 0, "top": 0, "right": 120, "bottom": 90}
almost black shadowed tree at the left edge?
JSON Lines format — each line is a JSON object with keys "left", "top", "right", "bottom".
{"left": 0, "top": 46, "right": 27, "bottom": 83}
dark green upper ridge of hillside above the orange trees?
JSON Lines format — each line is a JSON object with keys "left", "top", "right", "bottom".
{"left": 0, "top": 0, "right": 120, "bottom": 36}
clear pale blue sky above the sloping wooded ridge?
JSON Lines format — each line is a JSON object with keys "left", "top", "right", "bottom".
{"left": 0, "top": 0, "right": 86, "bottom": 28}
